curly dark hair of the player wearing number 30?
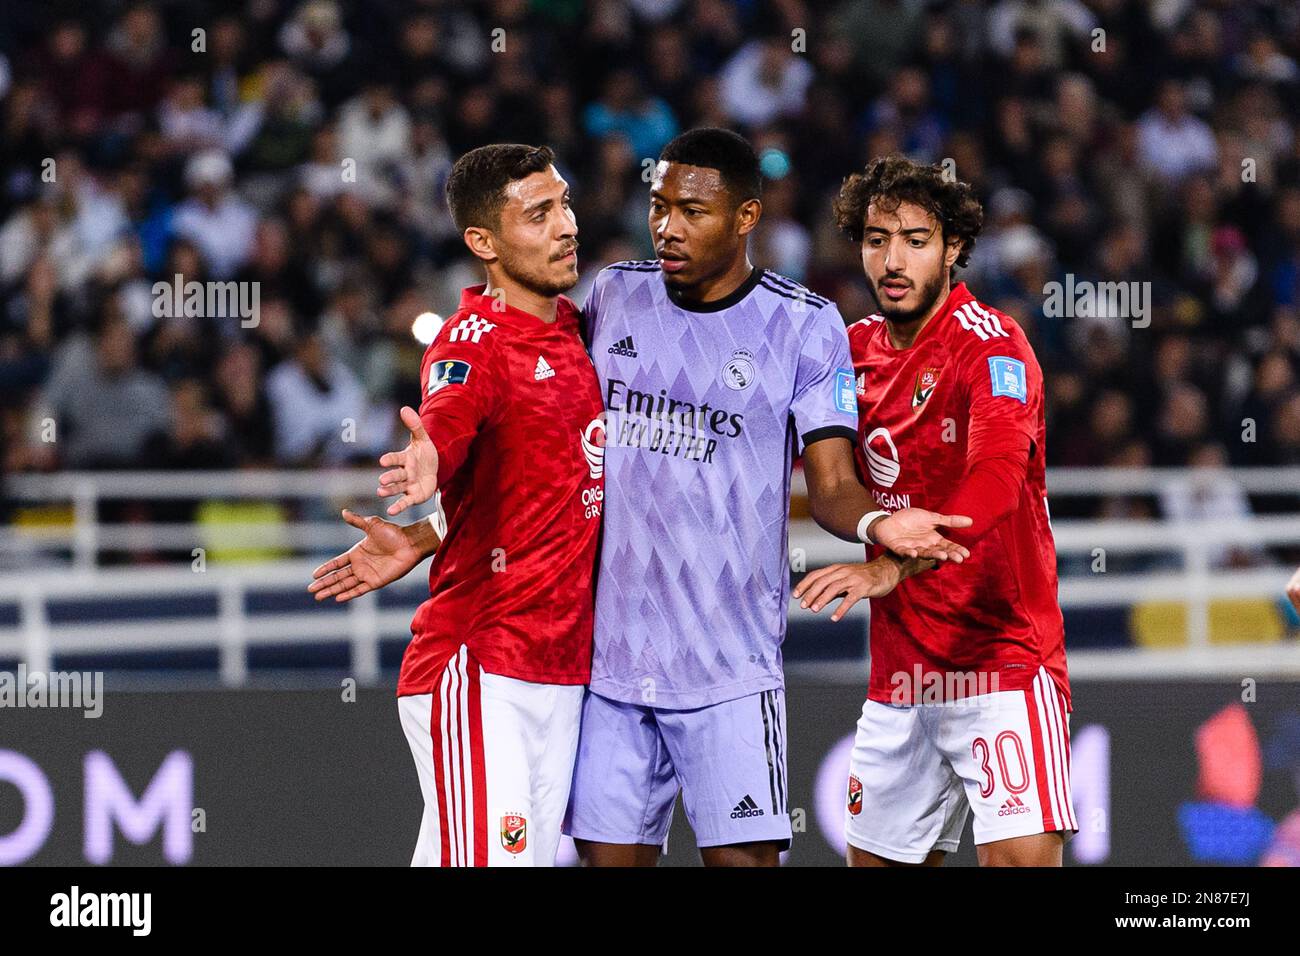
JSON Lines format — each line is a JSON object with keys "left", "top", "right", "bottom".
{"left": 835, "top": 156, "right": 984, "bottom": 267}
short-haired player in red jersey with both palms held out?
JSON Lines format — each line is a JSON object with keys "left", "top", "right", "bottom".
{"left": 309, "top": 144, "right": 605, "bottom": 866}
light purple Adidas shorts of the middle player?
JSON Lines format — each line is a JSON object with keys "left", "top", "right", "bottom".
{"left": 564, "top": 689, "right": 790, "bottom": 849}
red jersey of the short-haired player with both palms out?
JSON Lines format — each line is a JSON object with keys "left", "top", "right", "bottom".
{"left": 398, "top": 286, "right": 605, "bottom": 696}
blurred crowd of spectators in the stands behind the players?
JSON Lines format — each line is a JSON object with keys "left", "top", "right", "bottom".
{"left": 0, "top": 0, "right": 1300, "bottom": 530}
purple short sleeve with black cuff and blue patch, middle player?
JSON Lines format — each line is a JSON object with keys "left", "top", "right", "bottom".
{"left": 790, "top": 304, "right": 858, "bottom": 454}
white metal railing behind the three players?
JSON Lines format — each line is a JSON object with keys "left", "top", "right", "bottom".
{"left": 0, "top": 468, "right": 1300, "bottom": 685}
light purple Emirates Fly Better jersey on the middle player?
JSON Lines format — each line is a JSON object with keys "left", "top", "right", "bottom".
{"left": 585, "top": 260, "right": 858, "bottom": 710}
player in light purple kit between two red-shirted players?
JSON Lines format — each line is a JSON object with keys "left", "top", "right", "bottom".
{"left": 566, "top": 129, "right": 969, "bottom": 866}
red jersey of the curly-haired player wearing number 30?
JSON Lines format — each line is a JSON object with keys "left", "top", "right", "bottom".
{"left": 849, "top": 284, "right": 1070, "bottom": 704}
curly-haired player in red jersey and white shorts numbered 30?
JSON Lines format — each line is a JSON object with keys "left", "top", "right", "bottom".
{"left": 794, "top": 157, "right": 1078, "bottom": 866}
